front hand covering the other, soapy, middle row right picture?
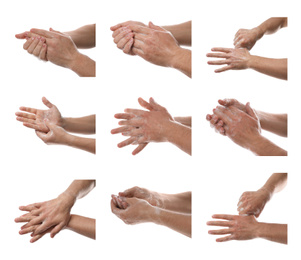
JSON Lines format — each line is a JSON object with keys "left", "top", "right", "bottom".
{"left": 213, "top": 103, "right": 261, "bottom": 149}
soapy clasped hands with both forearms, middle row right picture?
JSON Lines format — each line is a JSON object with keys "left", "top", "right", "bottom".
{"left": 206, "top": 99, "right": 287, "bottom": 156}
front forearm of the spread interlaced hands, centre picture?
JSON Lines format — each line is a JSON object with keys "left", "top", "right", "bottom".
{"left": 165, "top": 121, "right": 191, "bottom": 155}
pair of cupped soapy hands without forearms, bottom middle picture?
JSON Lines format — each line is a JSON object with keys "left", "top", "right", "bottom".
{"left": 111, "top": 187, "right": 163, "bottom": 224}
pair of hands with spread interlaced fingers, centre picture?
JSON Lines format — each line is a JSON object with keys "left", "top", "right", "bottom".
{"left": 111, "top": 98, "right": 174, "bottom": 155}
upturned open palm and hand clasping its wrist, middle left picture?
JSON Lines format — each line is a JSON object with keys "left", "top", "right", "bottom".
{"left": 16, "top": 97, "right": 68, "bottom": 144}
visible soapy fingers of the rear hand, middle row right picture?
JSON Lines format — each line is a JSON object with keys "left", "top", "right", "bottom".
{"left": 206, "top": 98, "right": 247, "bottom": 135}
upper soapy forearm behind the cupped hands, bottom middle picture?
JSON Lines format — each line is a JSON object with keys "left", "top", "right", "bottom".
{"left": 161, "top": 191, "right": 191, "bottom": 214}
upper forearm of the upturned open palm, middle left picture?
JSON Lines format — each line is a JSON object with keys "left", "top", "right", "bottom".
{"left": 62, "top": 115, "right": 96, "bottom": 134}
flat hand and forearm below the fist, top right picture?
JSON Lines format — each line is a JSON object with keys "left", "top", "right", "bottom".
{"left": 207, "top": 47, "right": 287, "bottom": 80}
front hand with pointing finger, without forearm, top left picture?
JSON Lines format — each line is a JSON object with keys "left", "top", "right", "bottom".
{"left": 30, "top": 28, "right": 80, "bottom": 69}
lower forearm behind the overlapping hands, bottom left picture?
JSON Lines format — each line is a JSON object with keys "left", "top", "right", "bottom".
{"left": 66, "top": 215, "right": 96, "bottom": 239}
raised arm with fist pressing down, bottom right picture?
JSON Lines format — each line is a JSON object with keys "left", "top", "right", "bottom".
{"left": 237, "top": 173, "right": 287, "bottom": 218}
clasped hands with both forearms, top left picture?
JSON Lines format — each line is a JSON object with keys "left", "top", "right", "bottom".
{"left": 16, "top": 25, "right": 95, "bottom": 77}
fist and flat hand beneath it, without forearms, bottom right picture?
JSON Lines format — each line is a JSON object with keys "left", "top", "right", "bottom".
{"left": 207, "top": 188, "right": 271, "bottom": 242}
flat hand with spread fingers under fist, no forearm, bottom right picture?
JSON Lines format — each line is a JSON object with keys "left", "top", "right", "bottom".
{"left": 207, "top": 214, "right": 259, "bottom": 242}
